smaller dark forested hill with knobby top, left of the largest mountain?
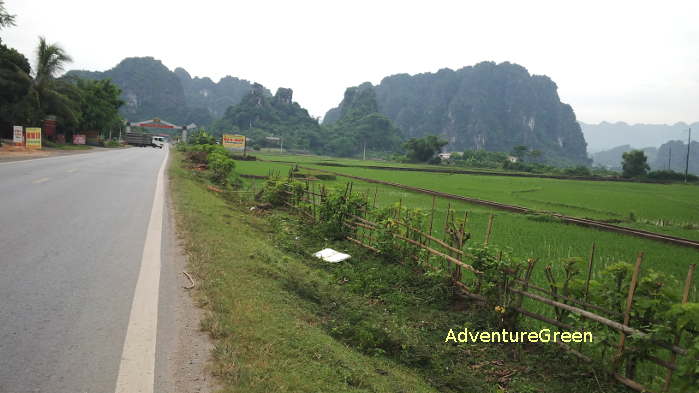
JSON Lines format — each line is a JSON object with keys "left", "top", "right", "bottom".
{"left": 213, "top": 83, "right": 323, "bottom": 151}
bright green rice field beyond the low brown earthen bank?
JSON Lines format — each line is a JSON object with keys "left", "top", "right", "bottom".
{"left": 294, "top": 164, "right": 699, "bottom": 239}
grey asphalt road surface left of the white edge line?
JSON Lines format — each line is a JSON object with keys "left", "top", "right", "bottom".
{"left": 0, "top": 148, "right": 185, "bottom": 393}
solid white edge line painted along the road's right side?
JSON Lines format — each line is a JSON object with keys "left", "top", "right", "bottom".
{"left": 115, "top": 148, "right": 169, "bottom": 393}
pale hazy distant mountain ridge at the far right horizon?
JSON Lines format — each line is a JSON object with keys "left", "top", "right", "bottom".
{"left": 580, "top": 121, "right": 699, "bottom": 153}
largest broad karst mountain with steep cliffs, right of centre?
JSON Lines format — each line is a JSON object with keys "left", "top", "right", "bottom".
{"left": 324, "top": 62, "right": 589, "bottom": 164}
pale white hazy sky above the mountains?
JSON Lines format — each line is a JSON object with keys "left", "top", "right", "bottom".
{"left": 0, "top": 0, "right": 699, "bottom": 123}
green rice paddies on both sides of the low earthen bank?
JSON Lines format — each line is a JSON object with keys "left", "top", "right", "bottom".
{"left": 231, "top": 157, "right": 699, "bottom": 292}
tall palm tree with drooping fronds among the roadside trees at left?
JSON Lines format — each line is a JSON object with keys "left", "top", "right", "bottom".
{"left": 32, "top": 37, "right": 79, "bottom": 123}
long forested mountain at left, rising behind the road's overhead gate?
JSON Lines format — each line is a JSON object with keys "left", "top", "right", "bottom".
{"left": 66, "top": 57, "right": 252, "bottom": 125}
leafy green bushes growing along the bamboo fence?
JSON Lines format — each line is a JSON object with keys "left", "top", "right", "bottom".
{"left": 263, "top": 179, "right": 699, "bottom": 390}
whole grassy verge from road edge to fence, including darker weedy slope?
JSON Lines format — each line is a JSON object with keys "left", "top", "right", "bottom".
{"left": 169, "top": 152, "right": 620, "bottom": 393}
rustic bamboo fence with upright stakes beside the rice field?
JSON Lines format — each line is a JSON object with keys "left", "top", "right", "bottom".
{"left": 278, "top": 182, "right": 696, "bottom": 393}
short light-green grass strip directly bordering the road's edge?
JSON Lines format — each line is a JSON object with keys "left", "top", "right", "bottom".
{"left": 169, "top": 152, "right": 435, "bottom": 393}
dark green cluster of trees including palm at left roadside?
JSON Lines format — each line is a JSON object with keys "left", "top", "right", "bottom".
{"left": 0, "top": 1, "right": 123, "bottom": 138}
